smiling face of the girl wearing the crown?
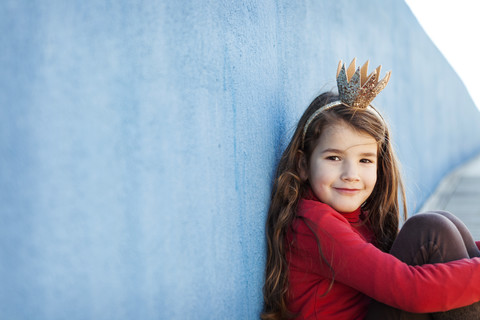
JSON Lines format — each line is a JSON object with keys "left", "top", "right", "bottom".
{"left": 302, "top": 121, "right": 378, "bottom": 212}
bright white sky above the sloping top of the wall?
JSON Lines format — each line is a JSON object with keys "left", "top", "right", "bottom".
{"left": 405, "top": 0, "right": 480, "bottom": 109}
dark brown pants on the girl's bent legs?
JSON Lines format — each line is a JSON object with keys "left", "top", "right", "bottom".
{"left": 365, "top": 211, "right": 480, "bottom": 320}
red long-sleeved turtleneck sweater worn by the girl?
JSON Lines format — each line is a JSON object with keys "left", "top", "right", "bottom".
{"left": 287, "top": 199, "right": 480, "bottom": 319}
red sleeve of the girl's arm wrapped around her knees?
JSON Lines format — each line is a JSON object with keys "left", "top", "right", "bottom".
{"left": 297, "top": 205, "right": 480, "bottom": 313}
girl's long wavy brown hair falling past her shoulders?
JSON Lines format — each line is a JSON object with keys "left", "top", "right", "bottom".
{"left": 261, "top": 92, "right": 407, "bottom": 320}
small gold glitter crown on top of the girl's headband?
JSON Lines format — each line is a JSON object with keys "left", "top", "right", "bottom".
{"left": 337, "top": 58, "right": 391, "bottom": 109}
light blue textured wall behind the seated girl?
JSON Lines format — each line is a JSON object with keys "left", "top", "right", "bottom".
{"left": 0, "top": 0, "right": 480, "bottom": 319}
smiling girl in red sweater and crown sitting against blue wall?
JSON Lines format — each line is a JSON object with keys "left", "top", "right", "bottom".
{"left": 261, "top": 59, "right": 480, "bottom": 320}
